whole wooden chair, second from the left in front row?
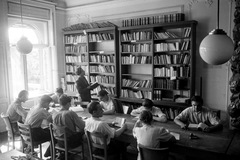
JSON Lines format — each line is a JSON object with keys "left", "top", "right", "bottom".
{"left": 17, "top": 122, "right": 46, "bottom": 159}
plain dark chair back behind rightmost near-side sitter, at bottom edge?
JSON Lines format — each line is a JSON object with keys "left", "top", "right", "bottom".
{"left": 138, "top": 144, "right": 169, "bottom": 160}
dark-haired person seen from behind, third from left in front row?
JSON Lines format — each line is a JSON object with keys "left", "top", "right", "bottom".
{"left": 53, "top": 95, "right": 85, "bottom": 148}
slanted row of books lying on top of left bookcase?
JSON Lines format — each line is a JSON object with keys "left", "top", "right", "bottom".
{"left": 62, "top": 21, "right": 115, "bottom": 31}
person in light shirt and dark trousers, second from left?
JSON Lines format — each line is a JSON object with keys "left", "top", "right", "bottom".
{"left": 24, "top": 95, "right": 52, "bottom": 157}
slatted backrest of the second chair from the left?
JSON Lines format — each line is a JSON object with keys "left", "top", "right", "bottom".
{"left": 17, "top": 122, "right": 34, "bottom": 151}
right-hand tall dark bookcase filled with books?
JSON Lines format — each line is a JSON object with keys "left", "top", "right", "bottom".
{"left": 119, "top": 21, "right": 197, "bottom": 119}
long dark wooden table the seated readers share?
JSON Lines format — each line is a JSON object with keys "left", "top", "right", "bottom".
{"left": 77, "top": 109, "right": 237, "bottom": 160}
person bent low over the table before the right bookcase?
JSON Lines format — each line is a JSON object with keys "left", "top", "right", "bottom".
{"left": 131, "top": 99, "right": 167, "bottom": 122}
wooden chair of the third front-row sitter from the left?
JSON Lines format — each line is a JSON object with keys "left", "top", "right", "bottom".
{"left": 49, "top": 123, "right": 84, "bottom": 160}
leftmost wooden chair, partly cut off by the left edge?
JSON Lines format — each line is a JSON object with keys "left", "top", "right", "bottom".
{"left": 1, "top": 113, "right": 21, "bottom": 151}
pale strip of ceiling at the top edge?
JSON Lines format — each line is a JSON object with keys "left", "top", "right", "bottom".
{"left": 54, "top": 0, "right": 114, "bottom": 8}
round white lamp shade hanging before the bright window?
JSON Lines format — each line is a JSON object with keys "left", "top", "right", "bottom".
{"left": 17, "top": 36, "right": 33, "bottom": 54}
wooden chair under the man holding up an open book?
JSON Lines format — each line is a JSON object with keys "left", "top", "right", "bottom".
{"left": 85, "top": 131, "right": 120, "bottom": 160}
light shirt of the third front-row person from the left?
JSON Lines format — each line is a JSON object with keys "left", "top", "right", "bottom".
{"left": 52, "top": 110, "right": 85, "bottom": 137}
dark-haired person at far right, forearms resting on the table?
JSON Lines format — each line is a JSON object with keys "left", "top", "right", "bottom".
{"left": 174, "top": 96, "right": 222, "bottom": 132}
